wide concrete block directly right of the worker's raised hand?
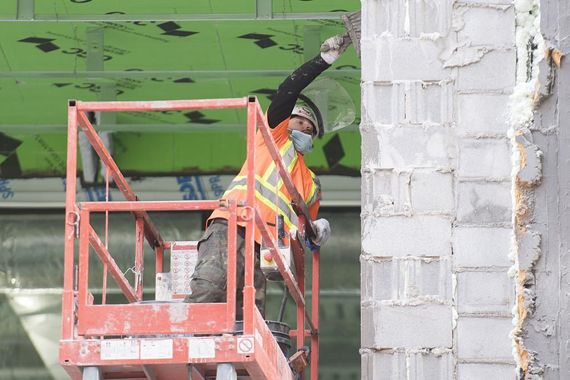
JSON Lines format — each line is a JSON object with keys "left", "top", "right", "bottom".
{"left": 361, "top": 37, "right": 450, "bottom": 82}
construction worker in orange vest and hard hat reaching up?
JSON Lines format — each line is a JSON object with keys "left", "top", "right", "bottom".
{"left": 185, "top": 36, "right": 350, "bottom": 320}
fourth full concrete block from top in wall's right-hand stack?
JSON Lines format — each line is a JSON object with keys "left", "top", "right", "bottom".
{"left": 457, "top": 137, "right": 512, "bottom": 179}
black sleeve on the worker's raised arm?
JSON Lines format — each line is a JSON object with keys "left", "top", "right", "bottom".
{"left": 267, "top": 54, "right": 331, "bottom": 128}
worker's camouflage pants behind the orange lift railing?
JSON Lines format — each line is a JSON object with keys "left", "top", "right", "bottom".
{"left": 184, "top": 222, "right": 265, "bottom": 320}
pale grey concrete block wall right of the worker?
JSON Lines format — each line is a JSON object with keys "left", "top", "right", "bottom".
{"left": 361, "top": 0, "right": 516, "bottom": 380}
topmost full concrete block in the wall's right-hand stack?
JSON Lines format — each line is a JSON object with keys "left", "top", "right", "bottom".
{"left": 453, "top": 6, "right": 515, "bottom": 47}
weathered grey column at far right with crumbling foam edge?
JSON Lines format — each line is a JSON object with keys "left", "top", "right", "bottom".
{"left": 511, "top": 0, "right": 570, "bottom": 380}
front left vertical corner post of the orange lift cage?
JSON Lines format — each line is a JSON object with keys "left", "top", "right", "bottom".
{"left": 61, "top": 100, "right": 79, "bottom": 340}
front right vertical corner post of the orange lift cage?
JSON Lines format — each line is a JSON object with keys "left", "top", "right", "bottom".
{"left": 243, "top": 96, "right": 257, "bottom": 335}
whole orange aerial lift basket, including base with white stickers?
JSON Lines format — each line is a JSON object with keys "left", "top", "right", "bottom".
{"left": 59, "top": 97, "right": 320, "bottom": 380}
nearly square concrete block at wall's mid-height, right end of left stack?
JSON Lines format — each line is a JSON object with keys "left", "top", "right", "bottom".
{"left": 411, "top": 170, "right": 455, "bottom": 214}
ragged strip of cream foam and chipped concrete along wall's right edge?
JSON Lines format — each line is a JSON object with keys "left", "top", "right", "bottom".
{"left": 509, "top": 0, "right": 553, "bottom": 379}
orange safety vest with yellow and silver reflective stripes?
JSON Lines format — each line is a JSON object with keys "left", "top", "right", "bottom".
{"left": 208, "top": 118, "right": 321, "bottom": 244}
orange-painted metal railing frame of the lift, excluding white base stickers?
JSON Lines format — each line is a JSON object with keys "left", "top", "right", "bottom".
{"left": 60, "top": 97, "right": 319, "bottom": 379}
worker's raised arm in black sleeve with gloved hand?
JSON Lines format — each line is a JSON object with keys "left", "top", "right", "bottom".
{"left": 267, "top": 36, "right": 350, "bottom": 128}
